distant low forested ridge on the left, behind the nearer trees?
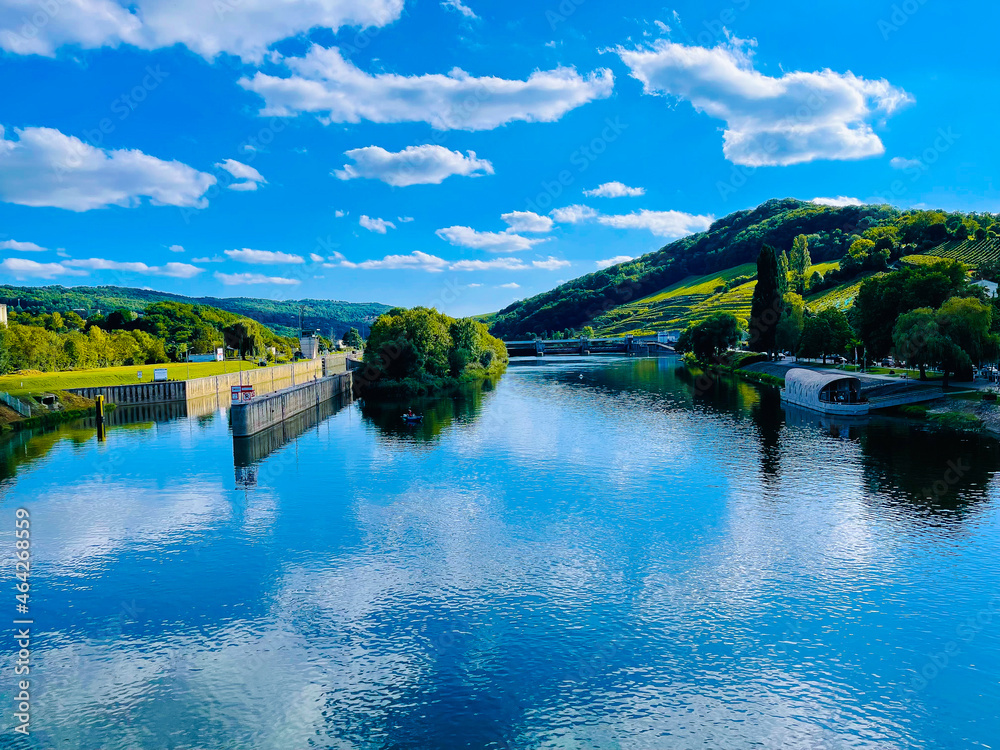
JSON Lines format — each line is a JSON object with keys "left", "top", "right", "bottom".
{"left": 0, "top": 286, "right": 390, "bottom": 337}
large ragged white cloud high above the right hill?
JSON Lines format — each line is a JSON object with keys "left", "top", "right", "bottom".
{"left": 615, "top": 38, "right": 913, "bottom": 167}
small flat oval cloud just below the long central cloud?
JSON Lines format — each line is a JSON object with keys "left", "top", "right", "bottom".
{"left": 334, "top": 144, "right": 493, "bottom": 187}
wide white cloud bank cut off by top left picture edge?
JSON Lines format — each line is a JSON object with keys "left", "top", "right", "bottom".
{"left": 0, "top": 0, "right": 403, "bottom": 62}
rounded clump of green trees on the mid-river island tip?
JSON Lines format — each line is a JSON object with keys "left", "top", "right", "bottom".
{"left": 362, "top": 307, "right": 508, "bottom": 394}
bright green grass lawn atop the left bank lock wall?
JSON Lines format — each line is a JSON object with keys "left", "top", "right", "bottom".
{"left": 0, "top": 361, "right": 278, "bottom": 396}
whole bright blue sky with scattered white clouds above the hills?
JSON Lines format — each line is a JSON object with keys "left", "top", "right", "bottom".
{"left": 0, "top": 0, "right": 1000, "bottom": 314}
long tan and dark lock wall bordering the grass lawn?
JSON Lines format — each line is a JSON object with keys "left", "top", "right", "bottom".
{"left": 67, "top": 354, "right": 347, "bottom": 406}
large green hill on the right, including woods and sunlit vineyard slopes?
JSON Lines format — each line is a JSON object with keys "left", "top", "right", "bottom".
{"left": 491, "top": 198, "right": 1000, "bottom": 339}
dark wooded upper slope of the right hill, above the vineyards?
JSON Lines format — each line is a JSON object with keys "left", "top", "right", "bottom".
{"left": 491, "top": 198, "right": 998, "bottom": 340}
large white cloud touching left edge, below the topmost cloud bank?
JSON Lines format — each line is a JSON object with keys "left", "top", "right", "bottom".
{"left": 0, "top": 126, "right": 215, "bottom": 211}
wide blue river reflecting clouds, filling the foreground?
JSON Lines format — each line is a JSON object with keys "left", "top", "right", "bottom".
{"left": 0, "top": 357, "right": 1000, "bottom": 750}
